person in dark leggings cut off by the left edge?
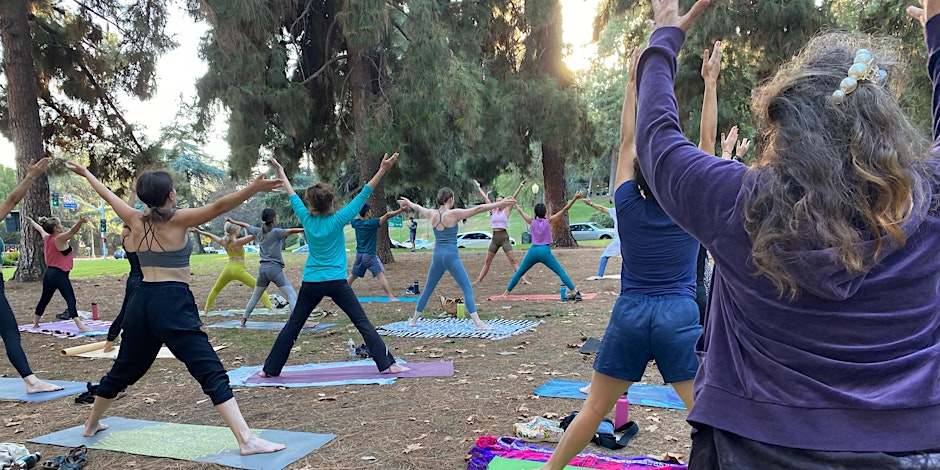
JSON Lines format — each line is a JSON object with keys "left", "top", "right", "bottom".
{"left": 0, "top": 157, "right": 62, "bottom": 393}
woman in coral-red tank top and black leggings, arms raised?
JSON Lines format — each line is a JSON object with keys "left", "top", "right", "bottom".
{"left": 26, "top": 216, "right": 91, "bottom": 331}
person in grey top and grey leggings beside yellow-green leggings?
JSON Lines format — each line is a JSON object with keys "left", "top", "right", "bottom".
{"left": 225, "top": 213, "right": 304, "bottom": 327}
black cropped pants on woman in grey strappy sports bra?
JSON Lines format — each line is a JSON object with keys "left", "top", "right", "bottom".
{"left": 96, "top": 282, "right": 233, "bottom": 405}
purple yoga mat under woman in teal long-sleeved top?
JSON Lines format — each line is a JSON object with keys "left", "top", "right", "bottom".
{"left": 245, "top": 361, "right": 454, "bottom": 384}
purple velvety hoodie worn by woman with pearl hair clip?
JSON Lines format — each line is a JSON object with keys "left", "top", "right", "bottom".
{"left": 636, "top": 23, "right": 940, "bottom": 452}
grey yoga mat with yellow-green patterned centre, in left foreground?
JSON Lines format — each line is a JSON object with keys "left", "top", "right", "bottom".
{"left": 29, "top": 416, "right": 336, "bottom": 470}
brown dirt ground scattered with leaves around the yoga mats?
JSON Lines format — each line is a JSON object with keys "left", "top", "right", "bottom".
{"left": 0, "top": 248, "right": 690, "bottom": 469}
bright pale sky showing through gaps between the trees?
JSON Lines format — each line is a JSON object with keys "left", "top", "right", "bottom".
{"left": 0, "top": 0, "right": 600, "bottom": 168}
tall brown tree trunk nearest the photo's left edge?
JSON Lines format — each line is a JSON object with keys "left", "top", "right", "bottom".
{"left": 0, "top": 0, "right": 51, "bottom": 282}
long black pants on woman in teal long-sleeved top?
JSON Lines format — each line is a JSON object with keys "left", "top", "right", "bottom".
{"left": 263, "top": 279, "right": 395, "bottom": 377}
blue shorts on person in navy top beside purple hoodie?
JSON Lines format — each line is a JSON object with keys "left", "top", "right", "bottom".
{"left": 594, "top": 294, "right": 702, "bottom": 383}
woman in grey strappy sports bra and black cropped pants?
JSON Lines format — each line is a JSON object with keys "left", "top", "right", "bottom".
{"left": 66, "top": 162, "right": 285, "bottom": 455}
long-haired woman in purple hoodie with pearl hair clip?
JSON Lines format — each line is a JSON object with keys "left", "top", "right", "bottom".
{"left": 636, "top": 0, "right": 940, "bottom": 469}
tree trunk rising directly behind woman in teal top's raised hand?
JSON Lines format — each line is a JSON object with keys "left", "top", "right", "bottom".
{"left": 348, "top": 48, "right": 395, "bottom": 264}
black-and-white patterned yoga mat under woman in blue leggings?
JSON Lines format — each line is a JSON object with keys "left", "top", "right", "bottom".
{"left": 376, "top": 318, "right": 542, "bottom": 340}
